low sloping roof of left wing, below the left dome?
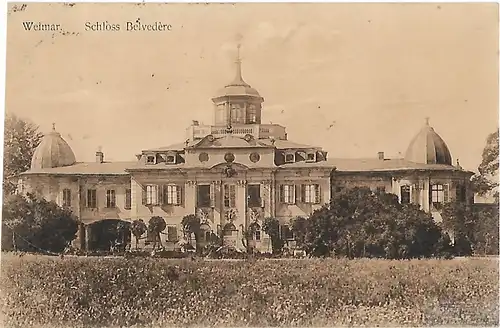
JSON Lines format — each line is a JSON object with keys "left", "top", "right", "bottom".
{"left": 22, "top": 162, "right": 136, "bottom": 175}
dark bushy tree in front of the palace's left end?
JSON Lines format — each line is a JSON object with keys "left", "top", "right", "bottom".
{"left": 2, "top": 194, "right": 78, "bottom": 252}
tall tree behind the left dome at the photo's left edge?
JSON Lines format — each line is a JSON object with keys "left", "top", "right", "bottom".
{"left": 3, "top": 113, "right": 43, "bottom": 195}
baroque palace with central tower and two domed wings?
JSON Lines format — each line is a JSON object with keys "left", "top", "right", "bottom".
{"left": 18, "top": 49, "right": 473, "bottom": 252}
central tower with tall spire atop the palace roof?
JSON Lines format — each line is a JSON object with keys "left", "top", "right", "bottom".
{"left": 212, "top": 44, "right": 264, "bottom": 127}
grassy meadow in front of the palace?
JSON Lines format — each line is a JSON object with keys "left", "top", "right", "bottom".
{"left": 1, "top": 254, "right": 499, "bottom": 327}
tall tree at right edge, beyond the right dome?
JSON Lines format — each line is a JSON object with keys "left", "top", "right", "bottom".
{"left": 472, "top": 130, "right": 499, "bottom": 202}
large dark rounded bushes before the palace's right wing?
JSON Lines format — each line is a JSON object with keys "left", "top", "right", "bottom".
{"left": 304, "top": 188, "right": 449, "bottom": 259}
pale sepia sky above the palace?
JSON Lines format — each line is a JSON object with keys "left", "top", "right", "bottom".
{"left": 6, "top": 3, "right": 499, "bottom": 170}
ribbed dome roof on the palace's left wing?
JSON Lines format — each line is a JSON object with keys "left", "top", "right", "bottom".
{"left": 31, "top": 124, "right": 76, "bottom": 170}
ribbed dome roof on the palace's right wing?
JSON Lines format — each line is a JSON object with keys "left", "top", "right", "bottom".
{"left": 405, "top": 119, "right": 452, "bottom": 165}
